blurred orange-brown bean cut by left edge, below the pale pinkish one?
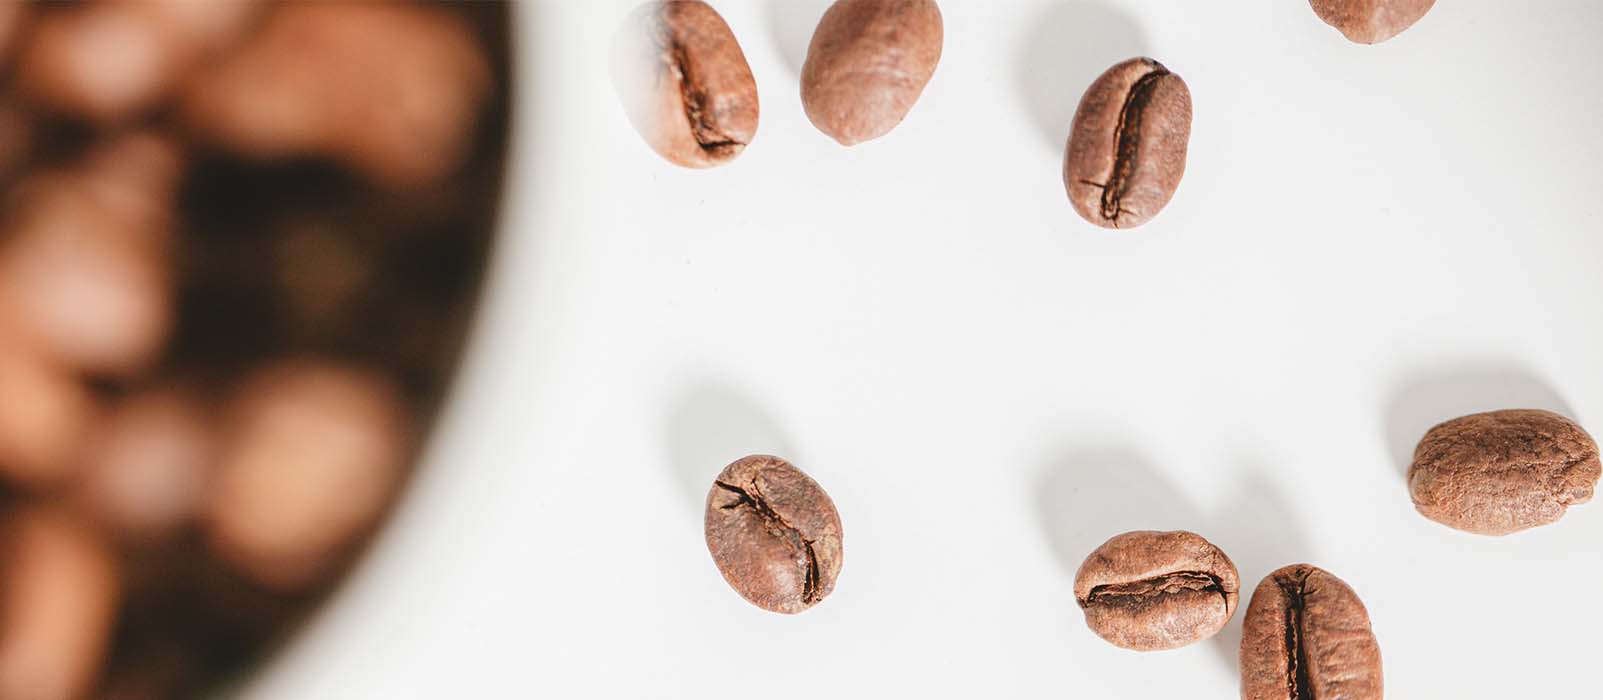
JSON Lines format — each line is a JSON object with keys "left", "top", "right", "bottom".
{"left": 0, "top": 331, "right": 96, "bottom": 486}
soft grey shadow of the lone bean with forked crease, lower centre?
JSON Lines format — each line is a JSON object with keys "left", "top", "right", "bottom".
{"left": 662, "top": 381, "right": 795, "bottom": 513}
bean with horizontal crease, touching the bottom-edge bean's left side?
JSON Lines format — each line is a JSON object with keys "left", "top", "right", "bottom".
{"left": 1074, "top": 530, "right": 1241, "bottom": 652}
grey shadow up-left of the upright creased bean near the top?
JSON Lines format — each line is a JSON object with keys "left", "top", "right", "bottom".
{"left": 1016, "top": 0, "right": 1146, "bottom": 151}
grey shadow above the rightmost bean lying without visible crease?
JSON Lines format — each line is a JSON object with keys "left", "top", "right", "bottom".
{"left": 1385, "top": 367, "right": 1574, "bottom": 476}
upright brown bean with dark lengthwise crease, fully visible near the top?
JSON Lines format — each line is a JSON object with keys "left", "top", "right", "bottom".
{"left": 1063, "top": 58, "right": 1191, "bottom": 229}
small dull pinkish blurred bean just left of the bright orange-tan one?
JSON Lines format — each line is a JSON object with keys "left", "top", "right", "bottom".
{"left": 79, "top": 386, "right": 213, "bottom": 541}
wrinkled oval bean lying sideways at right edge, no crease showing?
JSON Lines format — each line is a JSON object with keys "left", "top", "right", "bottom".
{"left": 1407, "top": 410, "right": 1603, "bottom": 535}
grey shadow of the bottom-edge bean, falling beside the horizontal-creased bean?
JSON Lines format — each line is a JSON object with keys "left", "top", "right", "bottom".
{"left": 1202, "top": 465, "right": 1318, "bottom": 671}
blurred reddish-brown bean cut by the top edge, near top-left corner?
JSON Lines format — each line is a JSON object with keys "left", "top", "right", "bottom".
{"left": 19, "top": 0, "right": 256, "bottom": 123}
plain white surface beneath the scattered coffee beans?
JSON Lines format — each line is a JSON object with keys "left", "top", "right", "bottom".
{"left": 247, "top": 0, "right": 1603, "bottom": 700}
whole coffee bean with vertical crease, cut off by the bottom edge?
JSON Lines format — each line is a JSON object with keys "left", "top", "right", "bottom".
{"left": 1241, "top": 564, "right": 1382, "bottom": 700}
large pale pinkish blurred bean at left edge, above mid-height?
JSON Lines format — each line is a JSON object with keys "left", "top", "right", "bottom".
{"left": 0, "top": 130, "right": 178, "bottom": 375}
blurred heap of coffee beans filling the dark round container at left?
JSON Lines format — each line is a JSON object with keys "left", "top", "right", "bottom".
{"left": 0, "top": 0, "right": 508, "bottom": 700}
